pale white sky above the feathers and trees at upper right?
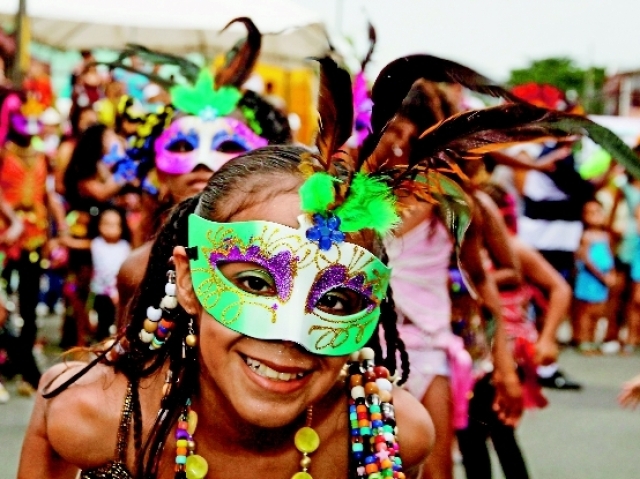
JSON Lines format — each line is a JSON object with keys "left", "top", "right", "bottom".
{"left": 295, "top": 0, "right": 640, "bottom": 81}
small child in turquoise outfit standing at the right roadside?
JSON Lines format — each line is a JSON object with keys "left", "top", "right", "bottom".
{"left": 573, "top": 199, "right": 615, "bottom": 355}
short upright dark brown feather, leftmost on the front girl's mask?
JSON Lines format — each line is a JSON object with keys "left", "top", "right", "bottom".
{"left": 316, "top": 57, "right": 353, "bottom": 167}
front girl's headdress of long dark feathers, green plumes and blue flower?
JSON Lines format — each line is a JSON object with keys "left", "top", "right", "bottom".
{"left": 300, "top": 55, "right": 640, "bottom": 249}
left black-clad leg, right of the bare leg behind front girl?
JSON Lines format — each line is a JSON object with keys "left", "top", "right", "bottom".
{"left": 456, "top": 376, "right": 493, "bottom": 479}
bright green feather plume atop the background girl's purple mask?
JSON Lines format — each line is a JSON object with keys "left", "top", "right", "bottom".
{"left": 170, "top": 68, "right": 242, "bottom": 116}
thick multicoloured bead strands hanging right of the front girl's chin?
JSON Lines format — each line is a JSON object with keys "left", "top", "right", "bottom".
{"left": 349, "top": 348, "right": 405, "bottom": 479}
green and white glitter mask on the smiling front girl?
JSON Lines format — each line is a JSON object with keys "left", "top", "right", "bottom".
{"left": 189, "top": 215, "right": 390, "bottom": 356}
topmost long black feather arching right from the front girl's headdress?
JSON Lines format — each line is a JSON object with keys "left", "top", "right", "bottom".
{"left": 371, "top": 55, "right": 520, "bottom": 132}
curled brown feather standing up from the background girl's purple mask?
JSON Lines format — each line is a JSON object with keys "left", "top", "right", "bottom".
{"left": 215, "top": 17, "right": 262, "bottom": 88}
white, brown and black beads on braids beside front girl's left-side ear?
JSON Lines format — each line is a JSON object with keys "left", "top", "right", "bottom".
{"left": 138, "top": 270, "right": 182, "bottom": 350}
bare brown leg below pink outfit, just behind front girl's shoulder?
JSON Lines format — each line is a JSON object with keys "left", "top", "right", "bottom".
{"left": 422, "top": 376, "right": 453, "bottom": 479}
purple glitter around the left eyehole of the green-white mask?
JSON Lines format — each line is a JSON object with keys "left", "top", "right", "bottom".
{"left": 209, "top": 242, "right": 298, "bottom": 301}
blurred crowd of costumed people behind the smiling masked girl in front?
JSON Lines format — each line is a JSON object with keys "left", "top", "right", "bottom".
{"left": 0, "top": 36, "right": 640, "bottom": 478}
